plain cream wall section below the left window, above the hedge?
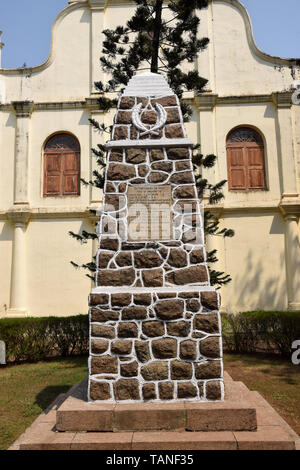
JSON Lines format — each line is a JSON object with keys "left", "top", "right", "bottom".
{"left": 26, "top": 218, "right": 92, "bottom": 316}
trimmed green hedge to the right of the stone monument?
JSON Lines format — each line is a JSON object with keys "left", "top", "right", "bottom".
{"left": 222, "top": 312, "right": 300, "bottom": 357}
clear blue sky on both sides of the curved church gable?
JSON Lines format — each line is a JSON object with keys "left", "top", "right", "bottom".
{"left": 0, "top": 0, "right": 300, "bottom": 68}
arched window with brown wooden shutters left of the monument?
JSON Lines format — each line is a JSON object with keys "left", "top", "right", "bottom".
{"left": 43, "top": 133, "right": 80, "bottom": 197}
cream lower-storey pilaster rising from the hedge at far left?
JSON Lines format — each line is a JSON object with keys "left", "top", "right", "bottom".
{"left": 7, "top": 207, "right": 31, "bottom": 316}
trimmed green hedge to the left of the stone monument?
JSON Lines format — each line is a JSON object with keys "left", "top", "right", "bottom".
{"left": 0, "top": 315, "right": 89, "bottom": 363}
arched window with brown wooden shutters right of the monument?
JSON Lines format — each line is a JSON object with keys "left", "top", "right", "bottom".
{"left": 227, "top": 127, "right": 266, "bottom": 191}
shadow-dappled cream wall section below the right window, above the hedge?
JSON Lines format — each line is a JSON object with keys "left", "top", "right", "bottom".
{"left": 219, "top": 212, "right": 287, "bottom": 313}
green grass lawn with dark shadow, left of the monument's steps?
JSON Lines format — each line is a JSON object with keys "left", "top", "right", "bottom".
{"left": 0, "top": 357, "right": 88, "bottom": 450}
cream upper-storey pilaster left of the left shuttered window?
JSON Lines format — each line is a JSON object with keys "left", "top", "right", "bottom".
{"left": 12, "top": 101, "right": 33, "bottom": 205}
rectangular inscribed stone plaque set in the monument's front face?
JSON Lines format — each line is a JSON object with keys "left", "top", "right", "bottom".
{"left": 127, "top": 185, "right": 173, "bottom": 241}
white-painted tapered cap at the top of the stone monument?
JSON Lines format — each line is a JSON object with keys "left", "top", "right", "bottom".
{"left": 123, "top": 72, "right": 174, "bottom": 98}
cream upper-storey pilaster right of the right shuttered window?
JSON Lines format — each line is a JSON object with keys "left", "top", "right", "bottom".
{"left": 272, "top": 92, "right": 299, "bottom": 200}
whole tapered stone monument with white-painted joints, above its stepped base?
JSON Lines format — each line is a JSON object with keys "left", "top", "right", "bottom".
{"left": 88, "top": 73, "right": 224, "bottom": 402}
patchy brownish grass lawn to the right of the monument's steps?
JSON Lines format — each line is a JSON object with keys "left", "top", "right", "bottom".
{"left": 224, "top": 354, "right": 300, "bottom": 435}
